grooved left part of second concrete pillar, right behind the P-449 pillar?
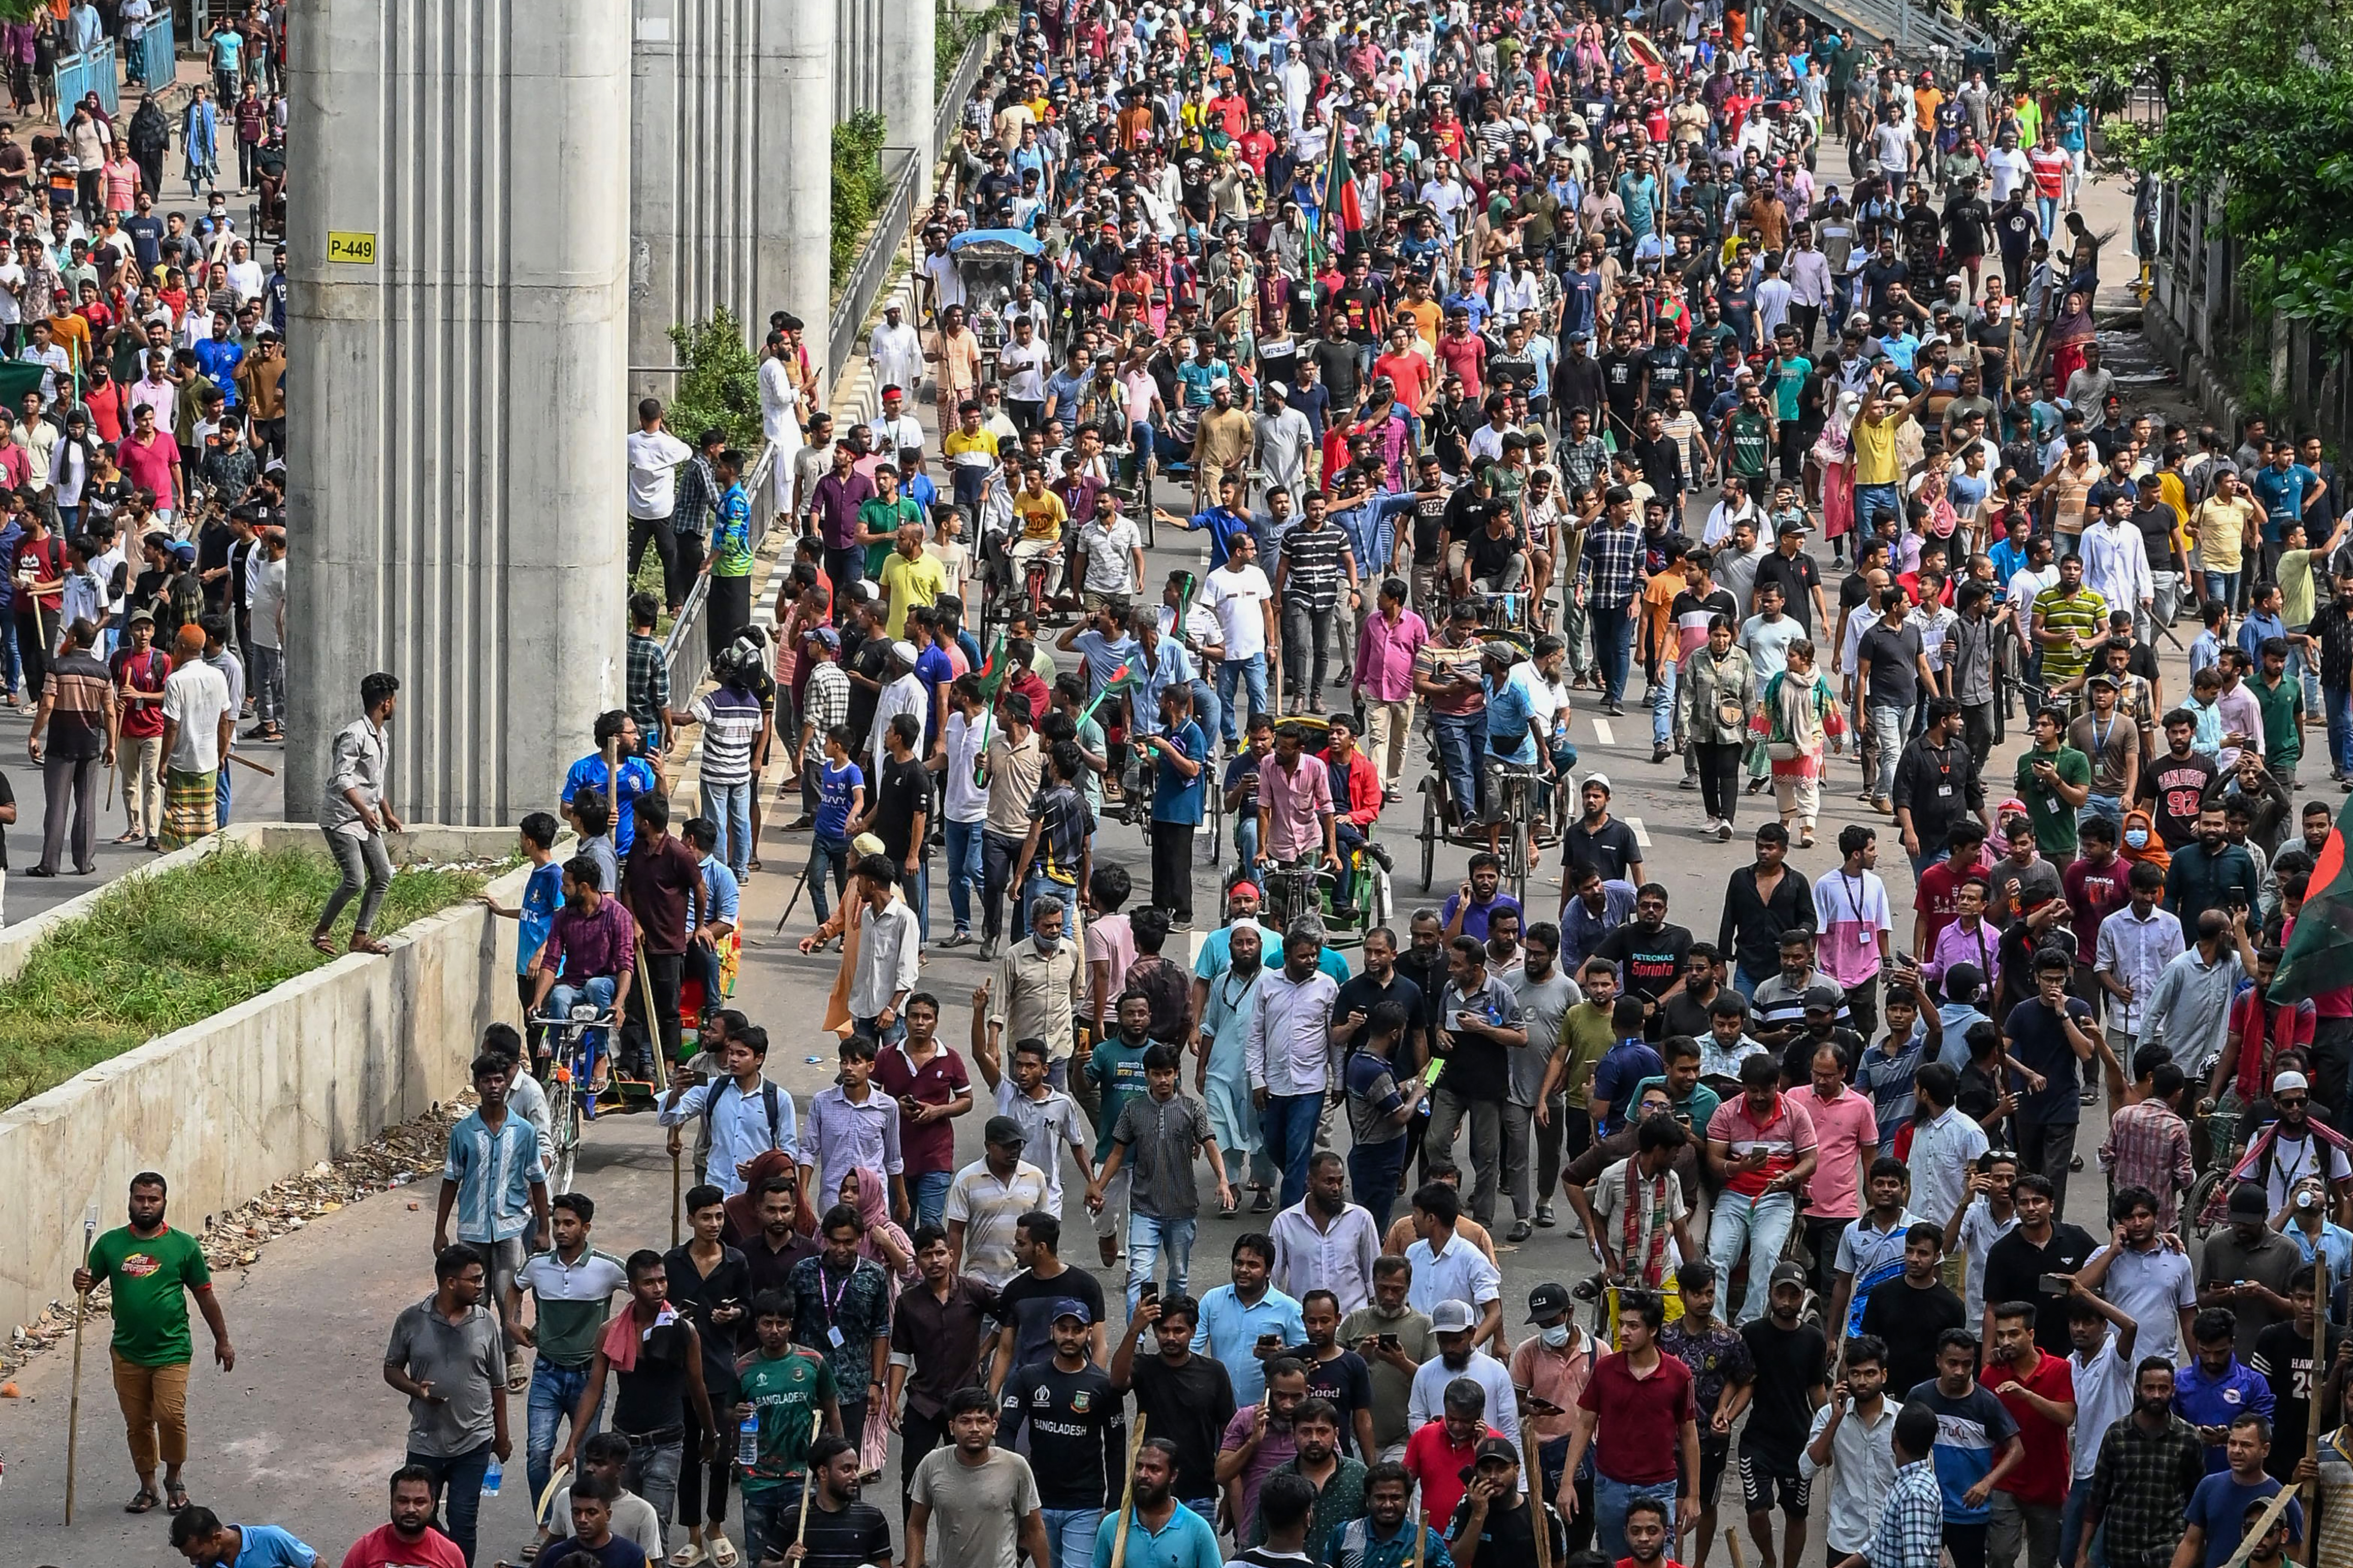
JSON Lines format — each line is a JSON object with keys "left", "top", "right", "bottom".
{"left": 628, "top": 0, "right": 767, "bottom": 404}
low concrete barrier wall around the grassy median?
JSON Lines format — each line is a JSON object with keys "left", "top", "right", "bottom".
{"left": 0, "top": 825, "right": 529, "bottom": 1326}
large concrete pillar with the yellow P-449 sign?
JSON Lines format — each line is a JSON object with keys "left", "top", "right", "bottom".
{"left": 287, "top": 0, "right": 631, "bottom": 825}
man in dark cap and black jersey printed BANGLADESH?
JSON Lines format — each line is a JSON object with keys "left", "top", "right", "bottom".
{"left": 997, "top": 1298, "right": 1127, "bottom": 1568}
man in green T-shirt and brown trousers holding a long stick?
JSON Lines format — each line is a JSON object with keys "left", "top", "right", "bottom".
{"left": 73, "top": 1171, "right": 238, "bottom": 1514}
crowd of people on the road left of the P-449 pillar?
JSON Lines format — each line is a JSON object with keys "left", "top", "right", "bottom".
{"left": 0, "top": 0, "right": 287, "bottom": 921}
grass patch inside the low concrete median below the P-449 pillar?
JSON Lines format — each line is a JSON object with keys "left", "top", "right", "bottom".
{"left": 0, "top": 844, "right": 501, "bottom": 1109}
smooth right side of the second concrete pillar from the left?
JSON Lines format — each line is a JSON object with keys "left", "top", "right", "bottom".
{"left": 746, "top": 0, "right": 840, "bottom": 385}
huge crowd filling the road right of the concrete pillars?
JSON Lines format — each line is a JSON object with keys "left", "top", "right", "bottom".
{"left": 37, "top": 0, "right": 2353, "bottom": 1568}
